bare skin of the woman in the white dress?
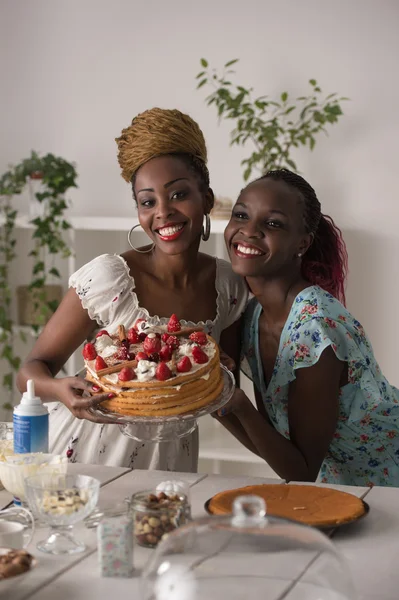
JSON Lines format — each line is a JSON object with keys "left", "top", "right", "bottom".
{"left": 17, "top": 156, "right": 239, "bottom": 423}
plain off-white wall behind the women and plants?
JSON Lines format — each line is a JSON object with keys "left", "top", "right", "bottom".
{"left": 0, "top": 0, "right": 399, "bottom": 384}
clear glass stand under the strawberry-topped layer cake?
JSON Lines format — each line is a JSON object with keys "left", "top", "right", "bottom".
{"left": 90, "top": 365, "right": 235, "bottom": 442}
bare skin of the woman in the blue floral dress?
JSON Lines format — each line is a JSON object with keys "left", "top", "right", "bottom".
{"left": 220, "top": 179, "right": 348, "bottom": 481}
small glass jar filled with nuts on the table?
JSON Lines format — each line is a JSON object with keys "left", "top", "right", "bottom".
{"left": 131, "top": 491, "right": 191, "bottom": 548}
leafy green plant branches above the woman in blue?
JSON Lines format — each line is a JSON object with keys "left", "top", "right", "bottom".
{"left": 196, "top": 58, "right": 348, "bottom": 181}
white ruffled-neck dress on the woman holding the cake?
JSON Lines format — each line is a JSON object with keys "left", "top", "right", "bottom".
{"left": 49, "top": 254, "right": 248, "bottom": 472}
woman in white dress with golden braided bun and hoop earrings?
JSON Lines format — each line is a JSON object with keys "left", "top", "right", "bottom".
{"left": 18, "top": 108, "right": 248, "bottom": 471}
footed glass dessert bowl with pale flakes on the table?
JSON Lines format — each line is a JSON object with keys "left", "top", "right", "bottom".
{"left": 25, "top": 473, "right": 100, "bottom": 554}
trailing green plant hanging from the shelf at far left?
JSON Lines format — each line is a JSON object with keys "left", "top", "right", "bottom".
{"left": 0, "top": 152, "right": 77, "bottom": 408}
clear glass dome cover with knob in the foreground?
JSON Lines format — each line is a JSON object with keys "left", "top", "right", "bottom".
{"left": 140, "top": 496, "right": 356, "bottom": 600}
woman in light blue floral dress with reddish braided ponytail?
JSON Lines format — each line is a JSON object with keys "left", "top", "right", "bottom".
{"left": 220, "top": 169, "right": 399, "bottom": 486}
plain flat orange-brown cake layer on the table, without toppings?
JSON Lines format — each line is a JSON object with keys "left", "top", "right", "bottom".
{"left": 208, "top": 484, "right": 365, "bottom": 527}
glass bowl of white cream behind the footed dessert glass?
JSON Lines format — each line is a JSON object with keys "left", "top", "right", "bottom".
{"left": 0, "top": 452, "right": 68, "bottom": 508}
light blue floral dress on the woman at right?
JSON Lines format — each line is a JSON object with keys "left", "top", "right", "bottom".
{"left": 242, "top": 286, "right": 399, "bottom": 486}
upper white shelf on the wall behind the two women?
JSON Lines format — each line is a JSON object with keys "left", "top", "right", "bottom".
{"left": 0, "top": 215, "right": 228, "bottom": 234}
